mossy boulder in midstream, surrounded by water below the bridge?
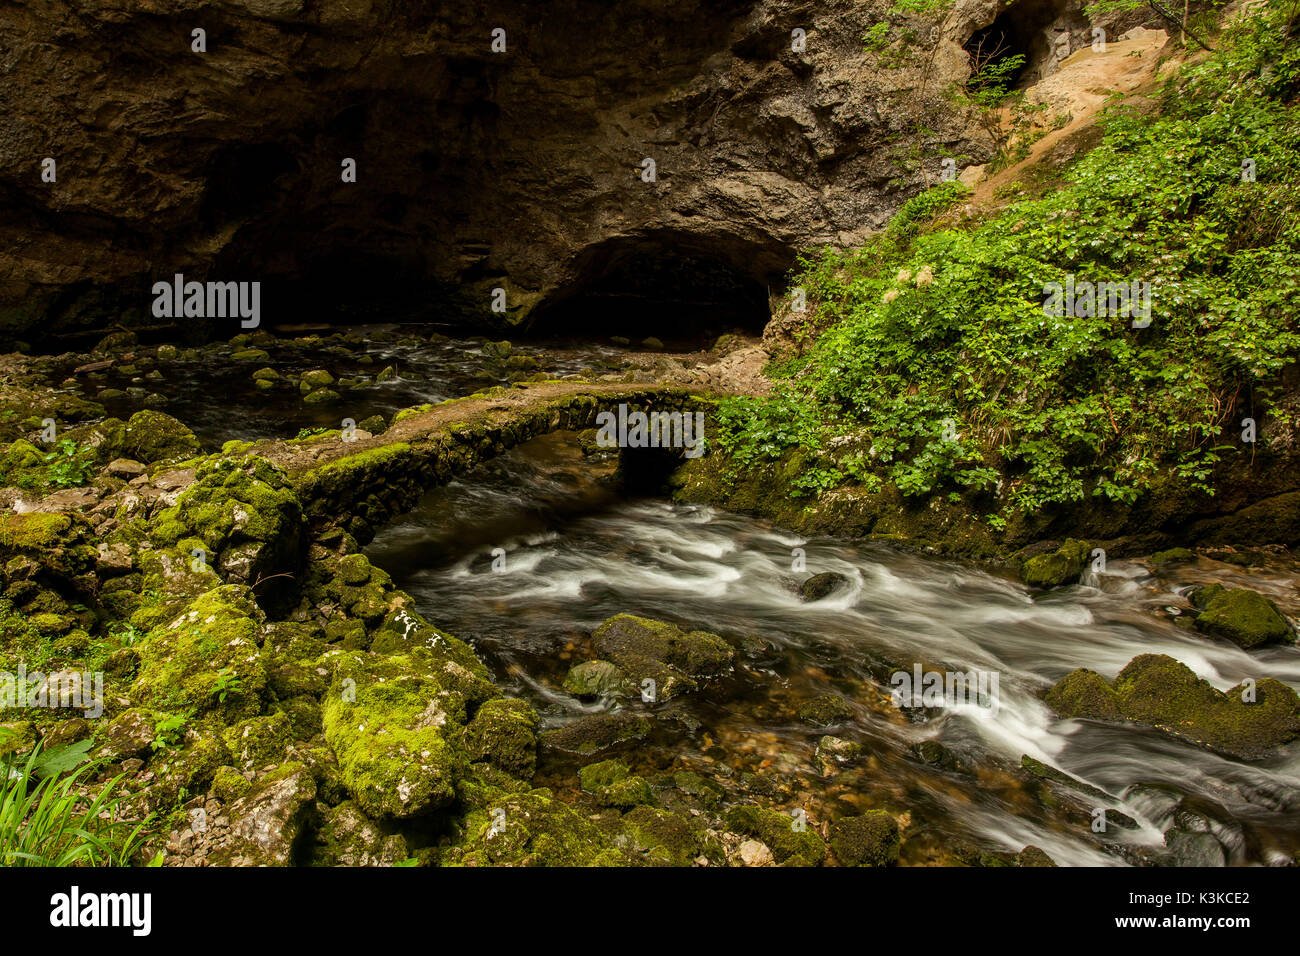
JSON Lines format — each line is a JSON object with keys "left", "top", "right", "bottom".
{"left": 592, "top": 614, "right": 736, "bottom": 700}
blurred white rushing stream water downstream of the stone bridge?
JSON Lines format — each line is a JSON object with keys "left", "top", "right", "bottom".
{"left": 368, "top": 436, "right": 1300, "bottom": 865}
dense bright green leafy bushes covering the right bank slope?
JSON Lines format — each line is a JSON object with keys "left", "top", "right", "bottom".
{"left": 720, "top": 16, "right": 1300, "bottom": 523}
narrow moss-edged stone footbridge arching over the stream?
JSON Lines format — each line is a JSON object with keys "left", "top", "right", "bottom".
{"left": 247, "top": 381, "right": 715, "bottom": 544}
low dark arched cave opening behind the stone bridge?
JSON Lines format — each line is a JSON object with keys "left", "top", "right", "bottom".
{"left": 529, "top": 235, "right": 793, "bottom": 349}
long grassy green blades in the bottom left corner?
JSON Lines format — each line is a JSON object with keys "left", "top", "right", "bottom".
{"left": 0, "top": 741, "right": 150, "bottom": 866}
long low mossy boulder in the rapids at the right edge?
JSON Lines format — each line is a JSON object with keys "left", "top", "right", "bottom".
{"left": 1047, "top": 654, "right": 1300, "bottom": 760}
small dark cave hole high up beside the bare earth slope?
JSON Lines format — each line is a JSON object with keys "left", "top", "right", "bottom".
{"left": 962, "top": 0, "right": 1088, "bottom": 90}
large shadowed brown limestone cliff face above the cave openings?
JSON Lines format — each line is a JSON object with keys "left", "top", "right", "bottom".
{"left": 0, "top": 0, "right": 996, "bottom": 333}
